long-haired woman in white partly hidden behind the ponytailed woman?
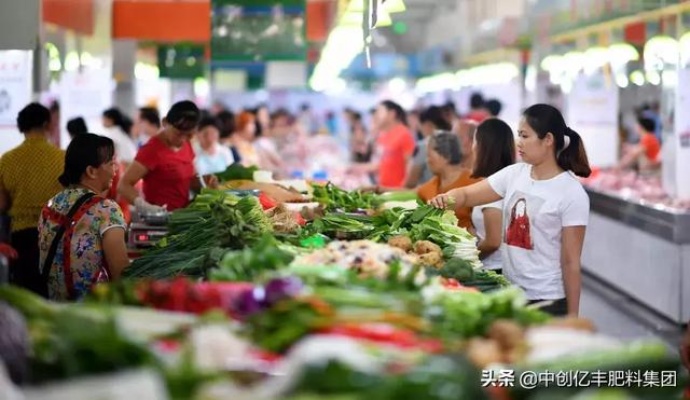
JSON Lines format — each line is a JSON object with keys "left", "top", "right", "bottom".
{"left": 472, "top": 118, "right": 515, "bottom": 274}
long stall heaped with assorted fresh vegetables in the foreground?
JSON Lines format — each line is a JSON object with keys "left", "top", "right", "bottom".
{"left": 0, "top": 176, "right": 684, "bottom": 400}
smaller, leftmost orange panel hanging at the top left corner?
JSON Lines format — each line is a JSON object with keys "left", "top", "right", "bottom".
{"left": 42, "top": 0, "right": 95, "bottom": 36}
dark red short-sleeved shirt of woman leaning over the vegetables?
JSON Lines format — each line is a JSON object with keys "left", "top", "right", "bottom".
{"left": 135, "top": 136, "right": 196, "bottom": 211}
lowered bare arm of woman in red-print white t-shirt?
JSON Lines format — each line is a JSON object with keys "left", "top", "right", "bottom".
{"left": 561, "top": 226, "right": 586, "bottom": 316}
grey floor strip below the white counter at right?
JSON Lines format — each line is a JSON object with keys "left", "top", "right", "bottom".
{"left": 580, "top": 276, "right": 682, "bottom": 349}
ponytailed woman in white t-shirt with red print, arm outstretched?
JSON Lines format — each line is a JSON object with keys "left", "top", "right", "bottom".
{"left": 430, "top": 104, "right": 591, "bottom": 315}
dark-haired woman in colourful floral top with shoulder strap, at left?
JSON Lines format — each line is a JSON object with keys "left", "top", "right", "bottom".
{"left": 38, "top": 134, "right": 129, "bottom": 301}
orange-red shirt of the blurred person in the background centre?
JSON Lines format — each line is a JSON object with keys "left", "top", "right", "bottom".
{"left": 377, "top": 124, "right": 416, "bottom": 188}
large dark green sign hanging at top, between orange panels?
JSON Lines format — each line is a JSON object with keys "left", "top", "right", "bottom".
{"left": 211, "top": 0, "right": 307, "bottom": 62}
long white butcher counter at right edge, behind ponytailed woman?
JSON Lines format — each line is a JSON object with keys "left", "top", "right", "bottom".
{"left": 582, "top": 189, "right": 690, "bottom": 324}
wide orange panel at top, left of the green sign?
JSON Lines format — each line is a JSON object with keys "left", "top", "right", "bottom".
{"left": 113, "top": 0, "right": 211, "bottom": 42}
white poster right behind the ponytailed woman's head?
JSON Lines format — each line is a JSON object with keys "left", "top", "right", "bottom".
{"left": 566, "top": 73, "right": 620, "bottom": 168}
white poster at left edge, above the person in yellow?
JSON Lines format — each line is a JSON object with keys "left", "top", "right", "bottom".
{"left": 0, "top": 50, "right": 33, "bottom": 128}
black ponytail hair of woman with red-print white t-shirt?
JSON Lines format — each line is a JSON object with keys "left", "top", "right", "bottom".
{"left": 523, "top": 104, "right": 592, "bottom": 178}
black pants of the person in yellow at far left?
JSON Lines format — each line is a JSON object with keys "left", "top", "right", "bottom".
{"left": 10, "top": 228, "right": 48, "bottom": 297}
